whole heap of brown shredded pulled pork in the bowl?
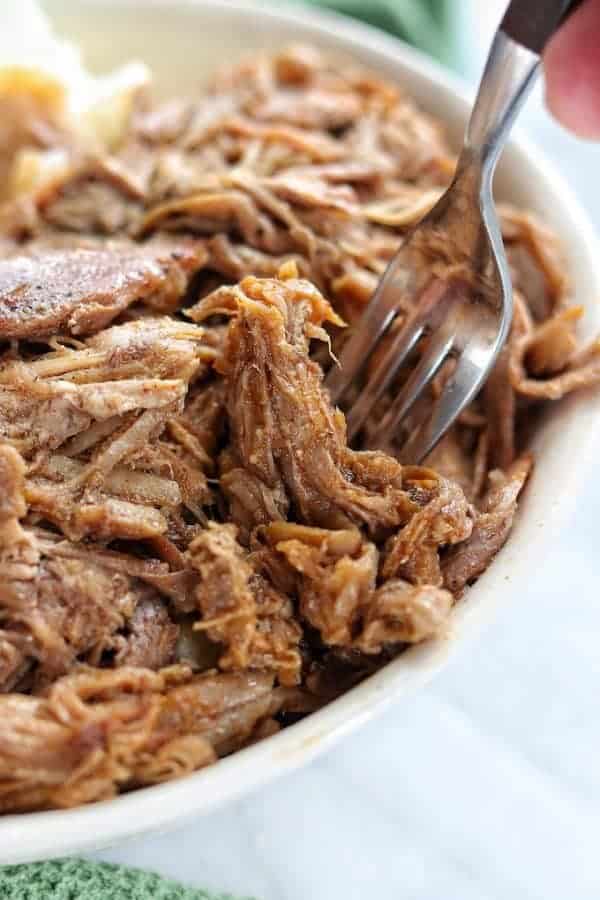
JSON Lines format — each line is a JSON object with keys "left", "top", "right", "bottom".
{"left": 0, "top": 47, "right": 600, "bottom": 812}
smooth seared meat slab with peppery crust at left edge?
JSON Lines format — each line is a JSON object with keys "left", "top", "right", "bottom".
{"left": 0, "top": 241, "right": 208, "bottom": 339}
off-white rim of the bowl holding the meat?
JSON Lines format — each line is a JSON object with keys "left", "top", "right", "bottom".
{"left": 0, "top": 0, "right": 600, "bottom": 864}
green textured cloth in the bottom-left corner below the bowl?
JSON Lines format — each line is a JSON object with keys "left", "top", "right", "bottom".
{"left": 0, "top": 859, "right": 255, "bottom": 900}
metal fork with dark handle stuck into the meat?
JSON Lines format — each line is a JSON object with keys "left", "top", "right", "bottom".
{"left": 325, "top": 0, "right": 580, "bottom": 463}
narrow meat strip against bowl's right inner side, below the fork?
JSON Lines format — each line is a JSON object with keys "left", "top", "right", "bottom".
{"left": 442, "top": 456, "right": 533, "bottom": 595}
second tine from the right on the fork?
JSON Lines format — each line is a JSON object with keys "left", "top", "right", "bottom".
{"left": 369, "top": 317, "right": 456, "bottom": 447}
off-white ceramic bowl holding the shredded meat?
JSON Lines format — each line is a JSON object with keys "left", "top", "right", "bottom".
{"left": 0, "top": 0, "right": 600, "bottom": 863}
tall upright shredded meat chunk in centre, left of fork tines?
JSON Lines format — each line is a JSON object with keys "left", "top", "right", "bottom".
{"left": 190, "top": 270, "right": 414, "bottom": 530}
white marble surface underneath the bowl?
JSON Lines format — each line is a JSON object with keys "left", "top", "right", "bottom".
{"left": 98, "top": 8, "right": 600, "bottom": 900}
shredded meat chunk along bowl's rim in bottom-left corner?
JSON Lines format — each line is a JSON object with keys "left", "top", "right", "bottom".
{"left": 0, "top": 666, "right": 278, "bottom": 812}
